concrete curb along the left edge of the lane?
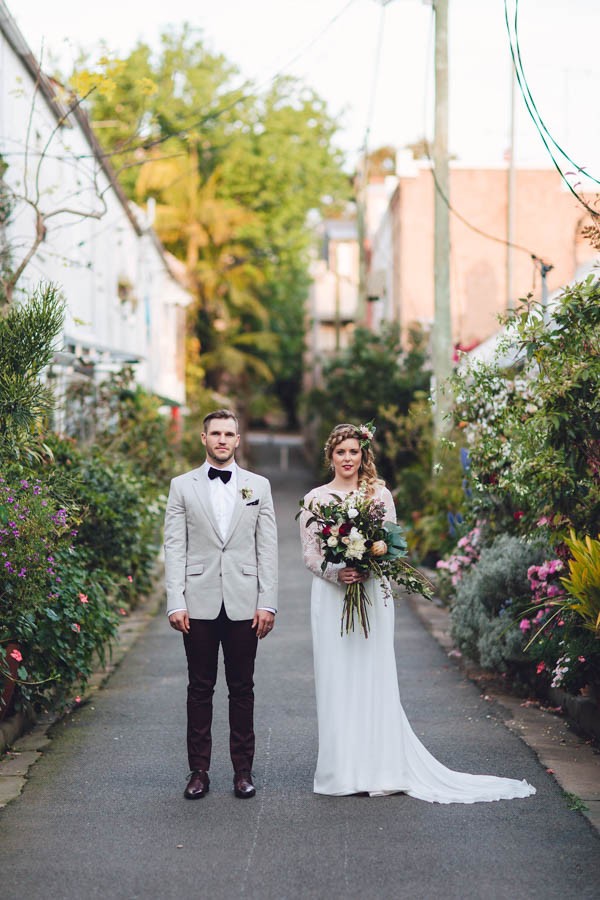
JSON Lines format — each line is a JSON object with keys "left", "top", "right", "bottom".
{"left": 0, "top": 564, "right": 164, "bottom": 809}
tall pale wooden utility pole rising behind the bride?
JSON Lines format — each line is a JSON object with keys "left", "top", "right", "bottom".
{"left": 432, "top": 0, "right": 452, "bottom": 444}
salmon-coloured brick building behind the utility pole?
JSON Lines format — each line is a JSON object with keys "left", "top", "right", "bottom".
{"left": 367, "top": 157, "right": 599, "bottom": 348}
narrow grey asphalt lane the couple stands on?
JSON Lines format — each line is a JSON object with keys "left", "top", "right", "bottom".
{"left": 0, "top": 454, "right": 600, "bottom": 900}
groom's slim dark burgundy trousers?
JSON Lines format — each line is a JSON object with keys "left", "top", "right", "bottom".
{"left": 183, "top": 606, "right": 258, "bottom": 772}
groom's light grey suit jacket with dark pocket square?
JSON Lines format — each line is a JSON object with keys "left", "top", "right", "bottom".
{"left": 165, "top": 463, "right": 277, "bottom": 621}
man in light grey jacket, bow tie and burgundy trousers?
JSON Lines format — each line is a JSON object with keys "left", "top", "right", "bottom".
{"left": 165, "top": 409, "right": 277, "bottom": 800}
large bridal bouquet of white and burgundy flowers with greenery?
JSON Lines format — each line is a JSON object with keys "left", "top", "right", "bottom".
{"left": 296, "top": 488, "right": 432, "bottom": 637}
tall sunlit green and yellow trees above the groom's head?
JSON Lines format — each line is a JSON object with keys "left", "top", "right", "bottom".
{"left": 75, "top": 25, "right": 350, "bottom": 424}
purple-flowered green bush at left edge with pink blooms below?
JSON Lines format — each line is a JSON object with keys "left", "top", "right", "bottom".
{"left": 0, "top": 475, "right": 117, "bottom": 715}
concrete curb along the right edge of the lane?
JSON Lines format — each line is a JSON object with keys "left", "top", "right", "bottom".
{"left": 406, "top": 594, "right": 600, "bottom": 833}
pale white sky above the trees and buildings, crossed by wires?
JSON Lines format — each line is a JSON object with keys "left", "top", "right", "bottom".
{"left": 6, "top": 0, "right": 600, "bottom": 177}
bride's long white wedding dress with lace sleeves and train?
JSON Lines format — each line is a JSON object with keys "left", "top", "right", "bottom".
{"left": 300, "top": 486, "right": 535, "bottom": 803}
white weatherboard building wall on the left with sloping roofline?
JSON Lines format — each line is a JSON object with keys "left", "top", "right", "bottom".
{"left": 0, "top": 0, "right": 191, "bottom": 404}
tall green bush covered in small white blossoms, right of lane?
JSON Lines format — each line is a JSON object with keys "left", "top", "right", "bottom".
{"left": 453, "top": 276, "right": 600, "bottom": 533}
